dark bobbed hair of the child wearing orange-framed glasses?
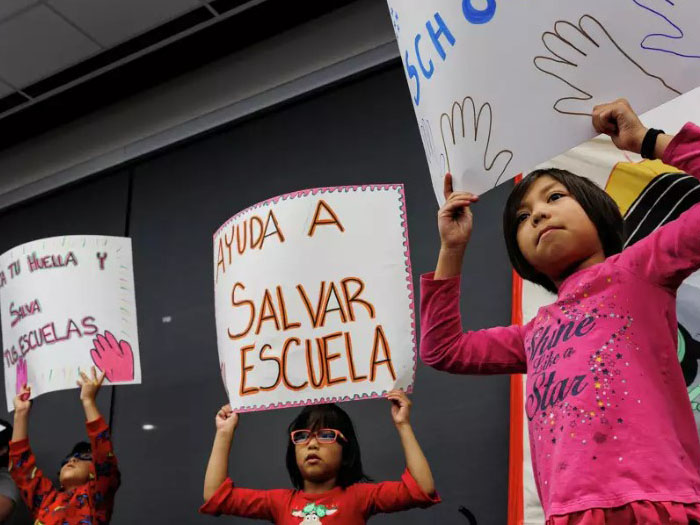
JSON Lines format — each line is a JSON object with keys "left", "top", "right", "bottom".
{"left": 286, "top": 404, "right": 370, "bottom": 490}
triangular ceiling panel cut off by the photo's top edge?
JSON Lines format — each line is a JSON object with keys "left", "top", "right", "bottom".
{"left": 48, "top": 0, "right": 202, "bottom": 47}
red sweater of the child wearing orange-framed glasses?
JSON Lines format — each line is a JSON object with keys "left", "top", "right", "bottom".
{"left": 200, "top": 470, "right": 440, "bottom": 525}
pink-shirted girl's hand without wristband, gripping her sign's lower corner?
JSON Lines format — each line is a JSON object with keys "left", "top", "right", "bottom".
{"left": 438, "top": 173, "right": 479, "bottom": 250}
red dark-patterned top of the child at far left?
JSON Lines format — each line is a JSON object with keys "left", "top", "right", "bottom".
{"left": 9, "top": 417, "right": 120, "bottom": 525}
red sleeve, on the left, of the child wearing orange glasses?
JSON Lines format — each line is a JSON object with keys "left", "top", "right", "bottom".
{"left": 199, "top": 478, "right": 291, "bottom": 521}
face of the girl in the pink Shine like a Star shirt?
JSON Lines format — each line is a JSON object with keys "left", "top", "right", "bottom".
{"left": 517, "top": 175, "right": 605, "bottom": 286}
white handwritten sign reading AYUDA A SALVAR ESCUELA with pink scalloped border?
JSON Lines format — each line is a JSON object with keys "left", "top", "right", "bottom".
{"left": 214, "top": 185, "right": 416, "bottom": 411}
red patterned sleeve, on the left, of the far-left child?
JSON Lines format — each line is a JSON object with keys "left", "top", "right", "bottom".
{"left": 8, "top": 439, "right": 57, "bottom": 516}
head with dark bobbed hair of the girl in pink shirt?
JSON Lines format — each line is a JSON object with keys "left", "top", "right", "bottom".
{"left": 503, "top": 168, "right": 623, "bottom": 293}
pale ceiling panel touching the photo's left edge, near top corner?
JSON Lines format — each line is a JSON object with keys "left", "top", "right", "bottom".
{"left": 0, "top": 5, "right": 99, "bottom": 87}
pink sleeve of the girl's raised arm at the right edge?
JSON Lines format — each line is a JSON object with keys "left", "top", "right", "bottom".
{"left": 615, "top": 123, "right": 700, "bottom": 292}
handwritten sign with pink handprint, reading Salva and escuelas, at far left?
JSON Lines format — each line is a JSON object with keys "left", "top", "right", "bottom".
{"left": 0, "top": 235, "right": 141, "bottom": 410}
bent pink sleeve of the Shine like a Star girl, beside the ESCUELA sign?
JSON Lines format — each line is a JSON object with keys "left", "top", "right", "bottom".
{"left": 420, "top": 273, "right": 526, "bottom": 374}
